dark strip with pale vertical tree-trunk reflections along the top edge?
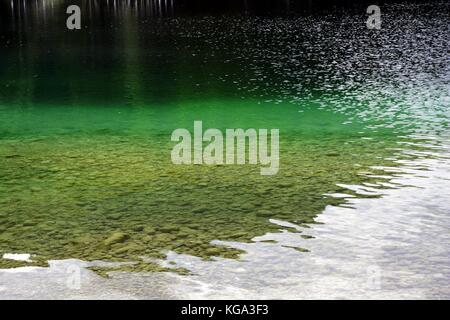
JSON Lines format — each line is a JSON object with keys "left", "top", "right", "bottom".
{"left": 0, "top": 0, "right": 334, "bottom": 21}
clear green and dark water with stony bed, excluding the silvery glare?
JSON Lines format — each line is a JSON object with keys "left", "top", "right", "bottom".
{"left": 0, "top": 1, "right": 448, "bottom": 272}
